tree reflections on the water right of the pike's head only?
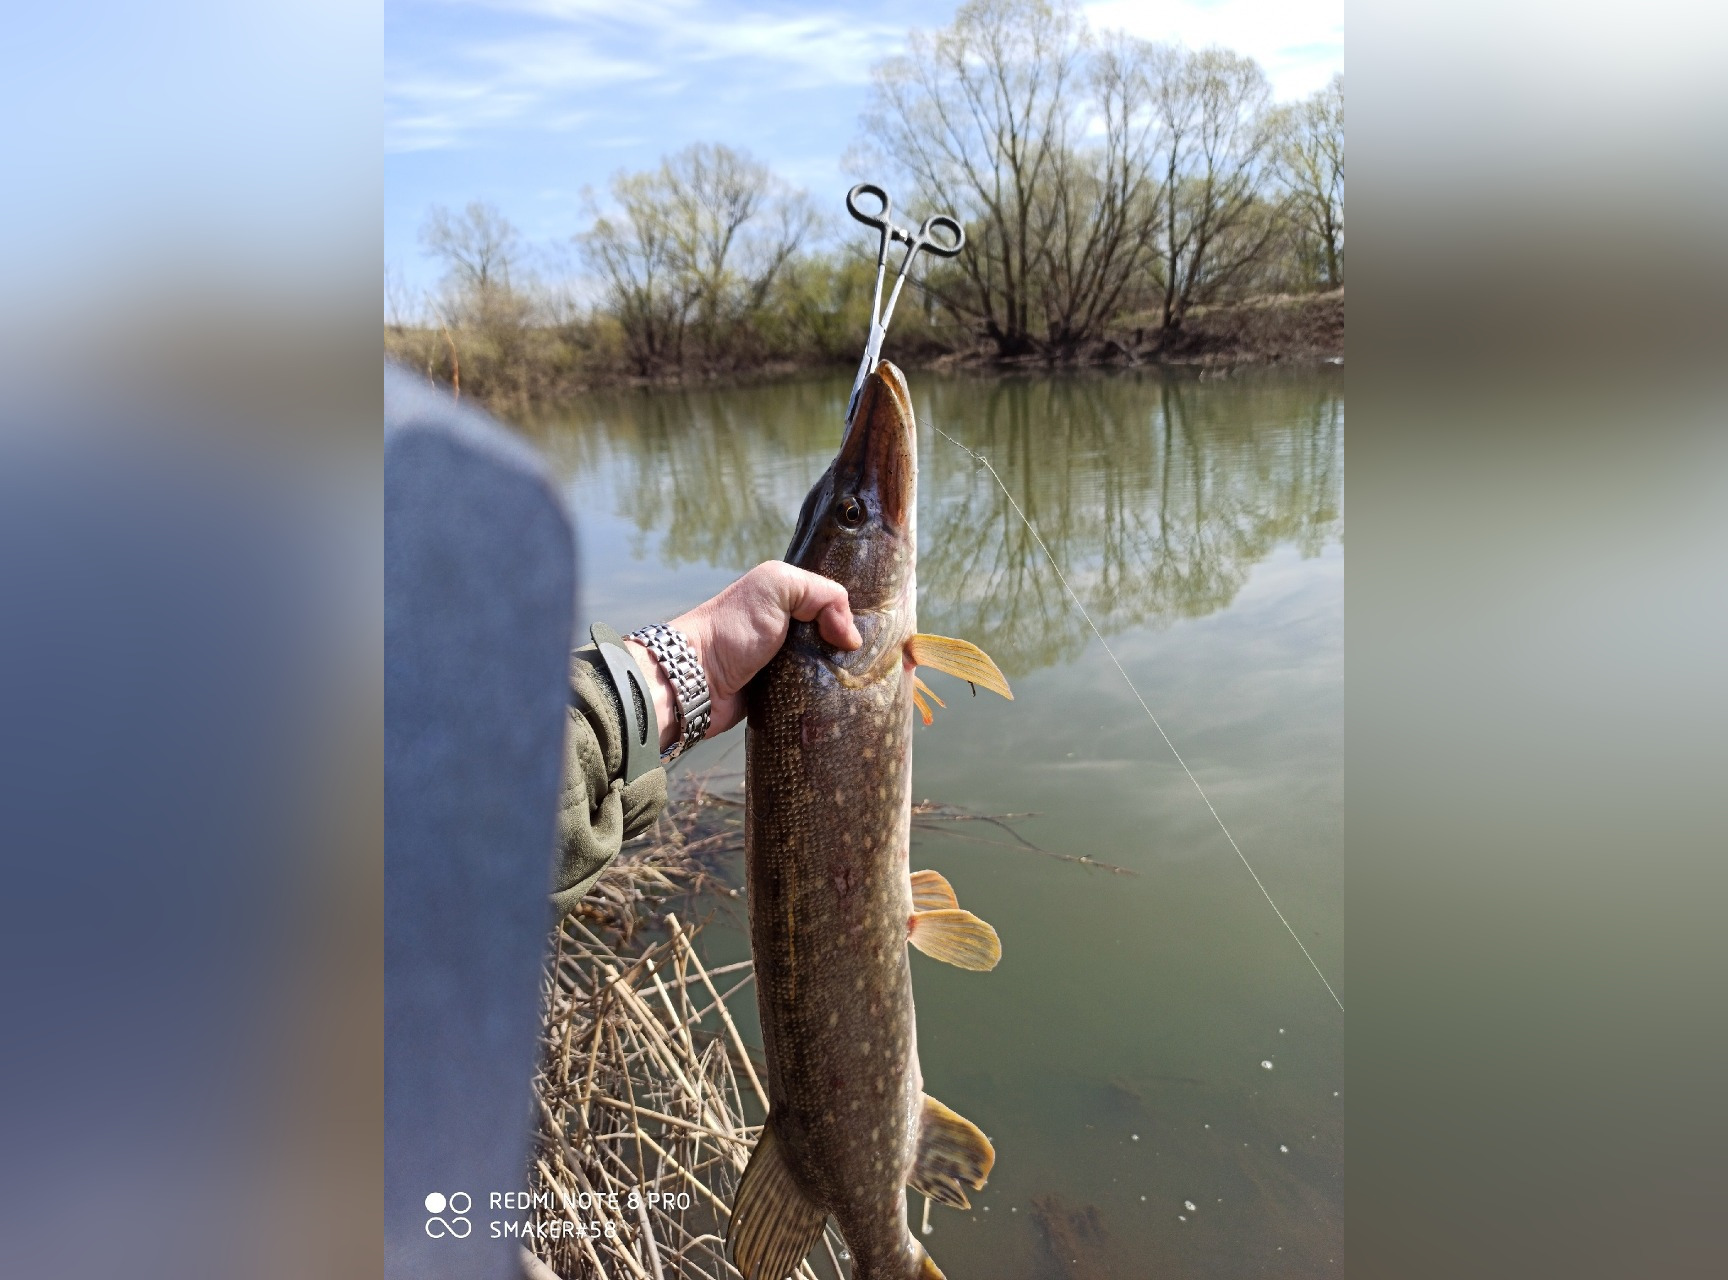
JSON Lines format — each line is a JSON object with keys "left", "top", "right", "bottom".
{"left": 919, "top": 369, "right": 1343, "bottom": 670}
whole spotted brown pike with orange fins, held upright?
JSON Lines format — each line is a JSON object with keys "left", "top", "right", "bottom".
{"left": 727, "top": 363, "right": 1013, "bottom": 1280}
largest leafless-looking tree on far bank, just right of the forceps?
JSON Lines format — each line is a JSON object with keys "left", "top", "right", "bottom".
{"left": 864, "top": 0, "right": 1237, "bottom": 356}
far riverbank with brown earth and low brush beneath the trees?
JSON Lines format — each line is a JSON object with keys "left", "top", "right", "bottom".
{"left": 384, "top": 288, "right": 1344, "bottom": 406}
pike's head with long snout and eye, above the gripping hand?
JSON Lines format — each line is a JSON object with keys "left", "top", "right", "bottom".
{"left": 786, "top": 361, "right": 918, "bottom": 635}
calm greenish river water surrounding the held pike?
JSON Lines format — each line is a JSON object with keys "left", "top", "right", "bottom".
{"left": 534, "top": 370, "right": 1350, "bottom": 1280}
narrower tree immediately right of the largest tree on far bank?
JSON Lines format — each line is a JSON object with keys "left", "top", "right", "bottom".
{"left": 1142, "top": 45, "right": 1277, "bottom": 333}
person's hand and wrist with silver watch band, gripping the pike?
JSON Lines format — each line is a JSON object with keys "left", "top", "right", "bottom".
{"left": 624, "top": 560, "right": 864, "bottom": 751}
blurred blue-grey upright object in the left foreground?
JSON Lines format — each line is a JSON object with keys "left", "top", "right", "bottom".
{"left": 384, "top": 368, "right": 575, "bottom": 1280}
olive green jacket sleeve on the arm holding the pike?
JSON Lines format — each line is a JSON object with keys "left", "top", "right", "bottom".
{"left": 551, "top": 644, "right": 665, "bottom": 916}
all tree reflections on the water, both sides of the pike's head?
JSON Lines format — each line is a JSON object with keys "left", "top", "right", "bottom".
{"left": 539, "top": 375, "right": 1344, "bottom": 674}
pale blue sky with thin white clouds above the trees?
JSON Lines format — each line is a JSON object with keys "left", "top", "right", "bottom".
{"left": 384, "top": 0, "right": 1344, "bottom": 297}
